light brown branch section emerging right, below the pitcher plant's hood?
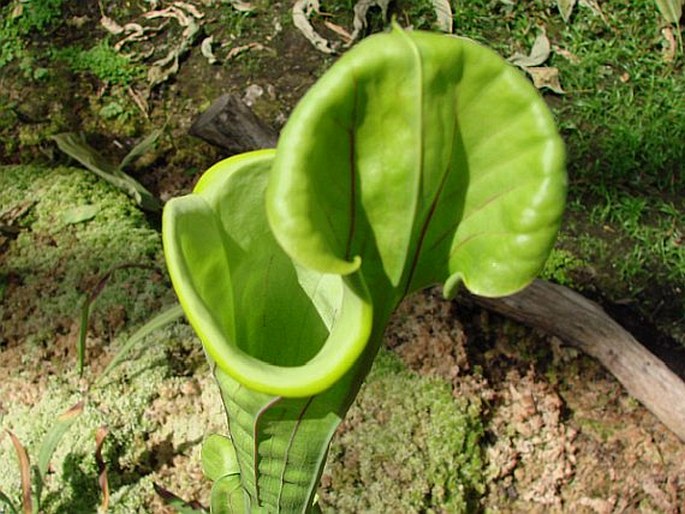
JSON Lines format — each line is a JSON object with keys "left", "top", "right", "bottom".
{"left": 469, "top": 280, "right": 685, "bottom": 441}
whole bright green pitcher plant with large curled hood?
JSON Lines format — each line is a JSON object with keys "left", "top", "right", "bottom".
{"left": 163, "top": 27, "right": 566, "bottom": 513}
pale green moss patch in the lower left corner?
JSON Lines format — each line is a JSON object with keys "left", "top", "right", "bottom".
{"left": 0, "top": 324, "right": 216, "bottom": 514}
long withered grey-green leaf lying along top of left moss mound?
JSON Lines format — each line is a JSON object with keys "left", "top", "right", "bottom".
{"left": 52, "top": 132, "right": 162, "bottom": 212}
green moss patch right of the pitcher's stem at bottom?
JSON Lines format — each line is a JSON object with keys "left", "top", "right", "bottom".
{"left": 321, "top": 352, "right": 485, "bottom": 513}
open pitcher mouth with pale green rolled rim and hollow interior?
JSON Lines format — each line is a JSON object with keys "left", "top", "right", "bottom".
{"left": 162, "top": 151, "right": 371, "bottom": 397}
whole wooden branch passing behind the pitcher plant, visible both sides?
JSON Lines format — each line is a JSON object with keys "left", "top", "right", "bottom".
{"left": 190, "top": 95, "right": 685, "bottom": 441}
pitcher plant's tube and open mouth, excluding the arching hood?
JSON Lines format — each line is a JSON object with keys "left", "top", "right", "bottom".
{"left": 162, "top": 151, "right": 382, "bottom": 512}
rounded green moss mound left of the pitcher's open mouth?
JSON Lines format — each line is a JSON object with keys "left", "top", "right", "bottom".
{"left": 0, "top": 166, "right": 171, "bottom": 342}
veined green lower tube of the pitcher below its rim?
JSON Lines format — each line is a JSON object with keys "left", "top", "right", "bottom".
{"left": 214, "top": 360, "right": 368, "bottom": 512}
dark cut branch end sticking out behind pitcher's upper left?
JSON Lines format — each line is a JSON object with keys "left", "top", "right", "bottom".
{"left": 188, "top": 94, "right": 278, "bottom": 154}
